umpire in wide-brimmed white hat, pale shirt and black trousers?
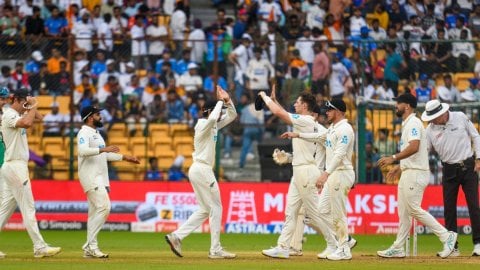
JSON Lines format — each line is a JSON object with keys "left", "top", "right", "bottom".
{"left": 422, "top": 100, "right": 480, "bottom": 256}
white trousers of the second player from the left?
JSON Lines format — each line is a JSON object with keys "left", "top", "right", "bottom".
{"left": 83, "top": 186, "right": 111, "bottom": 249}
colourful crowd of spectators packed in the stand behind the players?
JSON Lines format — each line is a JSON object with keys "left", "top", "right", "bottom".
{"left": 0, "top": 0, "right": 480, "bottom": 181}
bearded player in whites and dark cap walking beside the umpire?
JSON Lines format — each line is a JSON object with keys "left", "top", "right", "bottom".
{"left": 377, "top": 93, "right": 457, "bottom": 258}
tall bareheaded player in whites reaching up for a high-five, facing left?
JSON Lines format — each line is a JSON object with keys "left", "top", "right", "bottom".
{"left": 259, "top": 88, "right": 336, "bottom": 258}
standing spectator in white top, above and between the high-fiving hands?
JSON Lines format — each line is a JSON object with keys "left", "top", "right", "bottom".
{"left": 229, "top": 34, "right": 252, "bottom": 101}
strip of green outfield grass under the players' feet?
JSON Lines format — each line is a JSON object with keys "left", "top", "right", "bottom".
{"left": 0, "top": 231, "right": 480, "bottom": 270}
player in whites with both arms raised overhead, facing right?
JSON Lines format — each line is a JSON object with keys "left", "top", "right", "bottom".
{"left": 165, "top": 86, "right": 237, "bottom": 259}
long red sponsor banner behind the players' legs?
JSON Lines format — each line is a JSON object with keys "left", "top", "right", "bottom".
{"left": 6, "top": 181, "right": 471, "bottom": 234}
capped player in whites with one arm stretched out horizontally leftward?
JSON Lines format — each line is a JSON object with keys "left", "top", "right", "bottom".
{"left": 282, "top": 99, "right": 356, "bottom": 261}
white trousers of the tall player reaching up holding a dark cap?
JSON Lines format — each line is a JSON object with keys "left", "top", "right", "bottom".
{"left": 277, "top": 164, "right": 336, "bottom": 248}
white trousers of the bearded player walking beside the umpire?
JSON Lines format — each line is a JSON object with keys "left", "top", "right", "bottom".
{"left": 393, "top": 170, "right": 448, "bottom": 249}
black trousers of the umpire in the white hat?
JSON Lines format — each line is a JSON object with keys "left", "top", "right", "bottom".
{"left": 442, "top": 157, "right": 480, "bottom": 244}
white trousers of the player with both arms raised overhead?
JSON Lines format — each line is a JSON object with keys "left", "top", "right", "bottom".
{"left": 173, "top": 162, "right": 222, "bottom": 253}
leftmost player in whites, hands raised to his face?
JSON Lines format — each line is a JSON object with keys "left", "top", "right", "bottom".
{"left": 0, "top": 89, "right": 62, "bottom": 258}
